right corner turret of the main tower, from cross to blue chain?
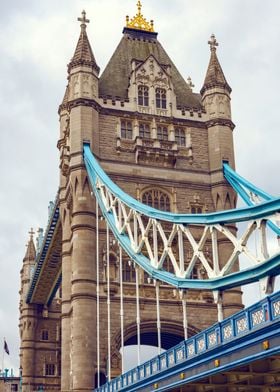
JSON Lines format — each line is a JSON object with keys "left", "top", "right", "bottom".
{"left": 200, "top": 34, "right": 236, "bottom": 210}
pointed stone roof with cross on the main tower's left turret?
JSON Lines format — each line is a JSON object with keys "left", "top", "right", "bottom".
{"left": 68, "top": 11, "right": 100, "bottom": 73}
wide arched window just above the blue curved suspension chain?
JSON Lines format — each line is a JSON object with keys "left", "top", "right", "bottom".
{"left": 140, "top": 187, "right": 173, "bottom": 212}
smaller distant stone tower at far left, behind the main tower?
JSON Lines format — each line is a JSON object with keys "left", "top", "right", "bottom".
{"left": 19, "top": 229, "right": 61, "bottom": 392}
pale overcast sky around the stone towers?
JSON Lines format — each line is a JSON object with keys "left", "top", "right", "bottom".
{"left": 0, "top": 0, "right": 280, "bottom": 376}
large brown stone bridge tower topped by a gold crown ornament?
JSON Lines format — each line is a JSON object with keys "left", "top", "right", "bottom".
{"left": 21, "top": 2, "right": 241, "bottom": 391}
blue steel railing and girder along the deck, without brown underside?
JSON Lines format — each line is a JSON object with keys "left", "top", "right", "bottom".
{"left": 95, "top": 292, "right": 280, "bottom": 392}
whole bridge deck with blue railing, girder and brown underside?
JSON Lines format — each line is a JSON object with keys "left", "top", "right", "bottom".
{"left": 96, "top": 292, "right": 280, "bottom": 392}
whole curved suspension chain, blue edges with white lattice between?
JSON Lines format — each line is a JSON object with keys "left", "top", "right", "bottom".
{"left": 84, "top": 145, "right": 280, "bottom": 290}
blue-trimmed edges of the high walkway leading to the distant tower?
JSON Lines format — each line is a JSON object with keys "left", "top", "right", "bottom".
{"left": 26, "top": 197, "right": 61, "bottom": 305}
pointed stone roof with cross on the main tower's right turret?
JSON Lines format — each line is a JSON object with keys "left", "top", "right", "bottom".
{"left": 200, "top": 34, "right": 231, "bottom": 94}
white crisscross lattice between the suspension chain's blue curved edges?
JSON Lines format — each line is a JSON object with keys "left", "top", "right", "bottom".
{"left": 96, "top": 174, "right": 279, "bottom": 291}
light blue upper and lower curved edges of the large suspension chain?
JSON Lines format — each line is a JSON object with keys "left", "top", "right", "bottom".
{"left": 84, "top": 145, "right": 280, "bottom": 290}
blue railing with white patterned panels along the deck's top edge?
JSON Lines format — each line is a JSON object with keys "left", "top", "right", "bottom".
{"left": 95, "top": 292, "right": 280, "bottom": 392}
